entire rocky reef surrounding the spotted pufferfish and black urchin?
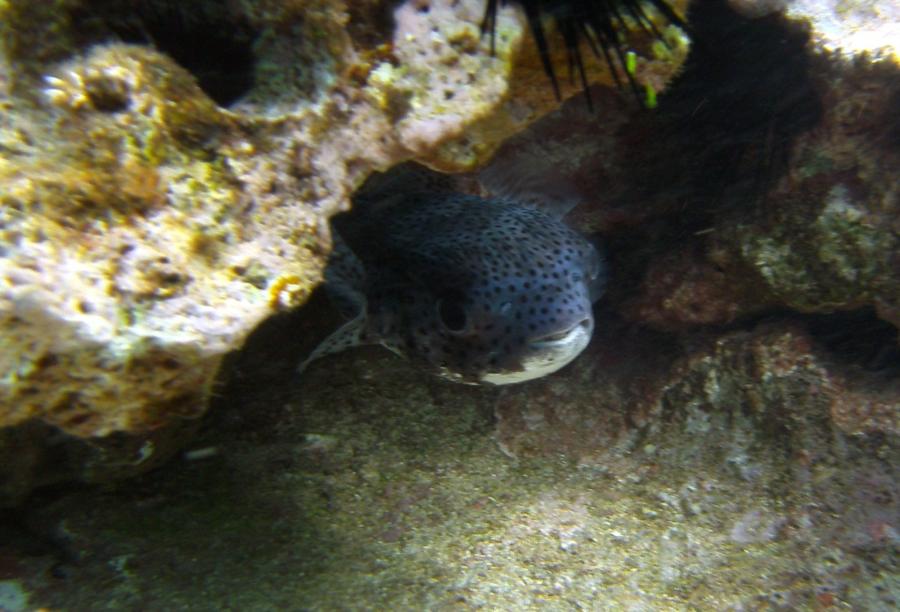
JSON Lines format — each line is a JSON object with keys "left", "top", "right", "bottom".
{"left": 0, "top": 0, "right": 900, "bottom": 611}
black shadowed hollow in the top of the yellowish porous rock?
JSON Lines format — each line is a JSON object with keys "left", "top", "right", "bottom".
{"left": 70, "top": 0, "right": 260, "bottom": 107}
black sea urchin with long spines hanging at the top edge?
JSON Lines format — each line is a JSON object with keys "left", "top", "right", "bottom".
{"left": 481, "top": 0, "right": 687, "bottom": 104}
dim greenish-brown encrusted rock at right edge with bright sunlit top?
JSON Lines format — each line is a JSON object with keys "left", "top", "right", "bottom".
{"left": 656, "top": 2, "right": 900, "bottom": 325}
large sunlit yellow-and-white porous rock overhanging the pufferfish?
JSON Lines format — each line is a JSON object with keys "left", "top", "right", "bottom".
{"left": 0, "top": 0, "right": 686, "bottom": 504}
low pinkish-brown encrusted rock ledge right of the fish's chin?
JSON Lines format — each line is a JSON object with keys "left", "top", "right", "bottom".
{"left": 497, "top": 318, "right": 900, "bottom": 466}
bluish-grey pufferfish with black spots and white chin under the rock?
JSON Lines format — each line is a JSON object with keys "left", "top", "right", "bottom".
{"left": 300, "top": 164, "right": 605, "bottom": 385}
